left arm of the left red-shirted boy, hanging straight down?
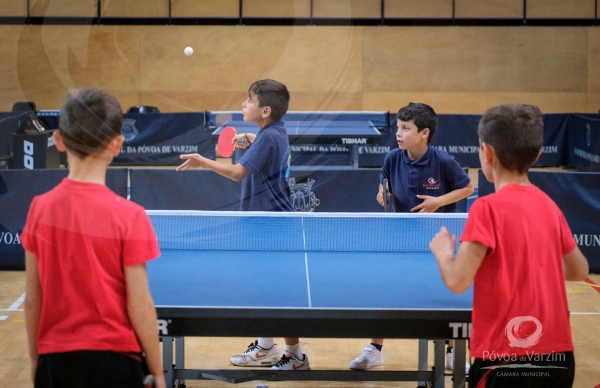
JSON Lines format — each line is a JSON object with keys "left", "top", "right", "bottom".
{"left": 25, "top": 251, "right": 43, "bottom": 382}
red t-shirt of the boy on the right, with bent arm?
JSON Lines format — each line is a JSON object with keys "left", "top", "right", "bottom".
{"left": 460, "top": 184, "right": 576, "bottom": 360}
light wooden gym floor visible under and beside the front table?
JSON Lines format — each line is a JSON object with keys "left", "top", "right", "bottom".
{"left": 0, "top": 271, "right": 600, "bottom": 388}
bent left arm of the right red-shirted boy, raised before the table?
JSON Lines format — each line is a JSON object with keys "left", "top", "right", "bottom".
{"left": 429, "top": 226, "right": 487, "bottom": 294}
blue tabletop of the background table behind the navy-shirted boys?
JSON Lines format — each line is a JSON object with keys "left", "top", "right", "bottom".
{"left": 213, "top": 120, "right": 381, "bottom": 136}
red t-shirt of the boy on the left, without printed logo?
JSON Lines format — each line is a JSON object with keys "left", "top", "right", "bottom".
{"left": 21, "top": 178, "right": 160, "bottom": 354}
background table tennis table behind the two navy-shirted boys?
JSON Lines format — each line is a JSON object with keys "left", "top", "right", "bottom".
{"left": 212, "top": 119, "right": 381, "bottom": 169}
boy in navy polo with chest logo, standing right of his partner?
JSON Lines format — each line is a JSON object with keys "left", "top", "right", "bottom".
{"left": 350, "top": 103, "right": 474, "bottom": 369}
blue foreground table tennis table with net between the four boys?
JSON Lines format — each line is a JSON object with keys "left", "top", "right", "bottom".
{"left": 147, "top": 211, "right": 473, "bottom": 387}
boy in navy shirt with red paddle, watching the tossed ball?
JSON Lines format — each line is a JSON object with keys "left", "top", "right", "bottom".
{"left": 177, "top": 79, "right": 310, "bottom": 370}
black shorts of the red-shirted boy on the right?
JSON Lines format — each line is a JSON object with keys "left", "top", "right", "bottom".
{"left": 469, "top": 352, "right": 575, "bottom": 388}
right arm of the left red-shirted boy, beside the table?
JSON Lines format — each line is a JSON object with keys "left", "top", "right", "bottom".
{"left": 125, "top": 264, "right": 166, "bottom": 388}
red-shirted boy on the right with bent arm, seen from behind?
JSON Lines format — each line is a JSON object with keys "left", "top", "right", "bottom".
{"left": 430, "top": 104, "right": 589, "bottom": 388}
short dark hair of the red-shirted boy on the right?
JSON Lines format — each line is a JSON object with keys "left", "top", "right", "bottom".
{"left": 477, "top": 104, "right": 544, "bottom": 174}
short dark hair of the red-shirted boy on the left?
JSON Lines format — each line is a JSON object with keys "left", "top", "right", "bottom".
{"left": 59, "top": 88, "right": 123, "bottom": 159}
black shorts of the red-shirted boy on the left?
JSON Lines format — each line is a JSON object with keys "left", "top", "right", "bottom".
{"left": 35, "top": 350, "right": 144, "bottom": 388}
